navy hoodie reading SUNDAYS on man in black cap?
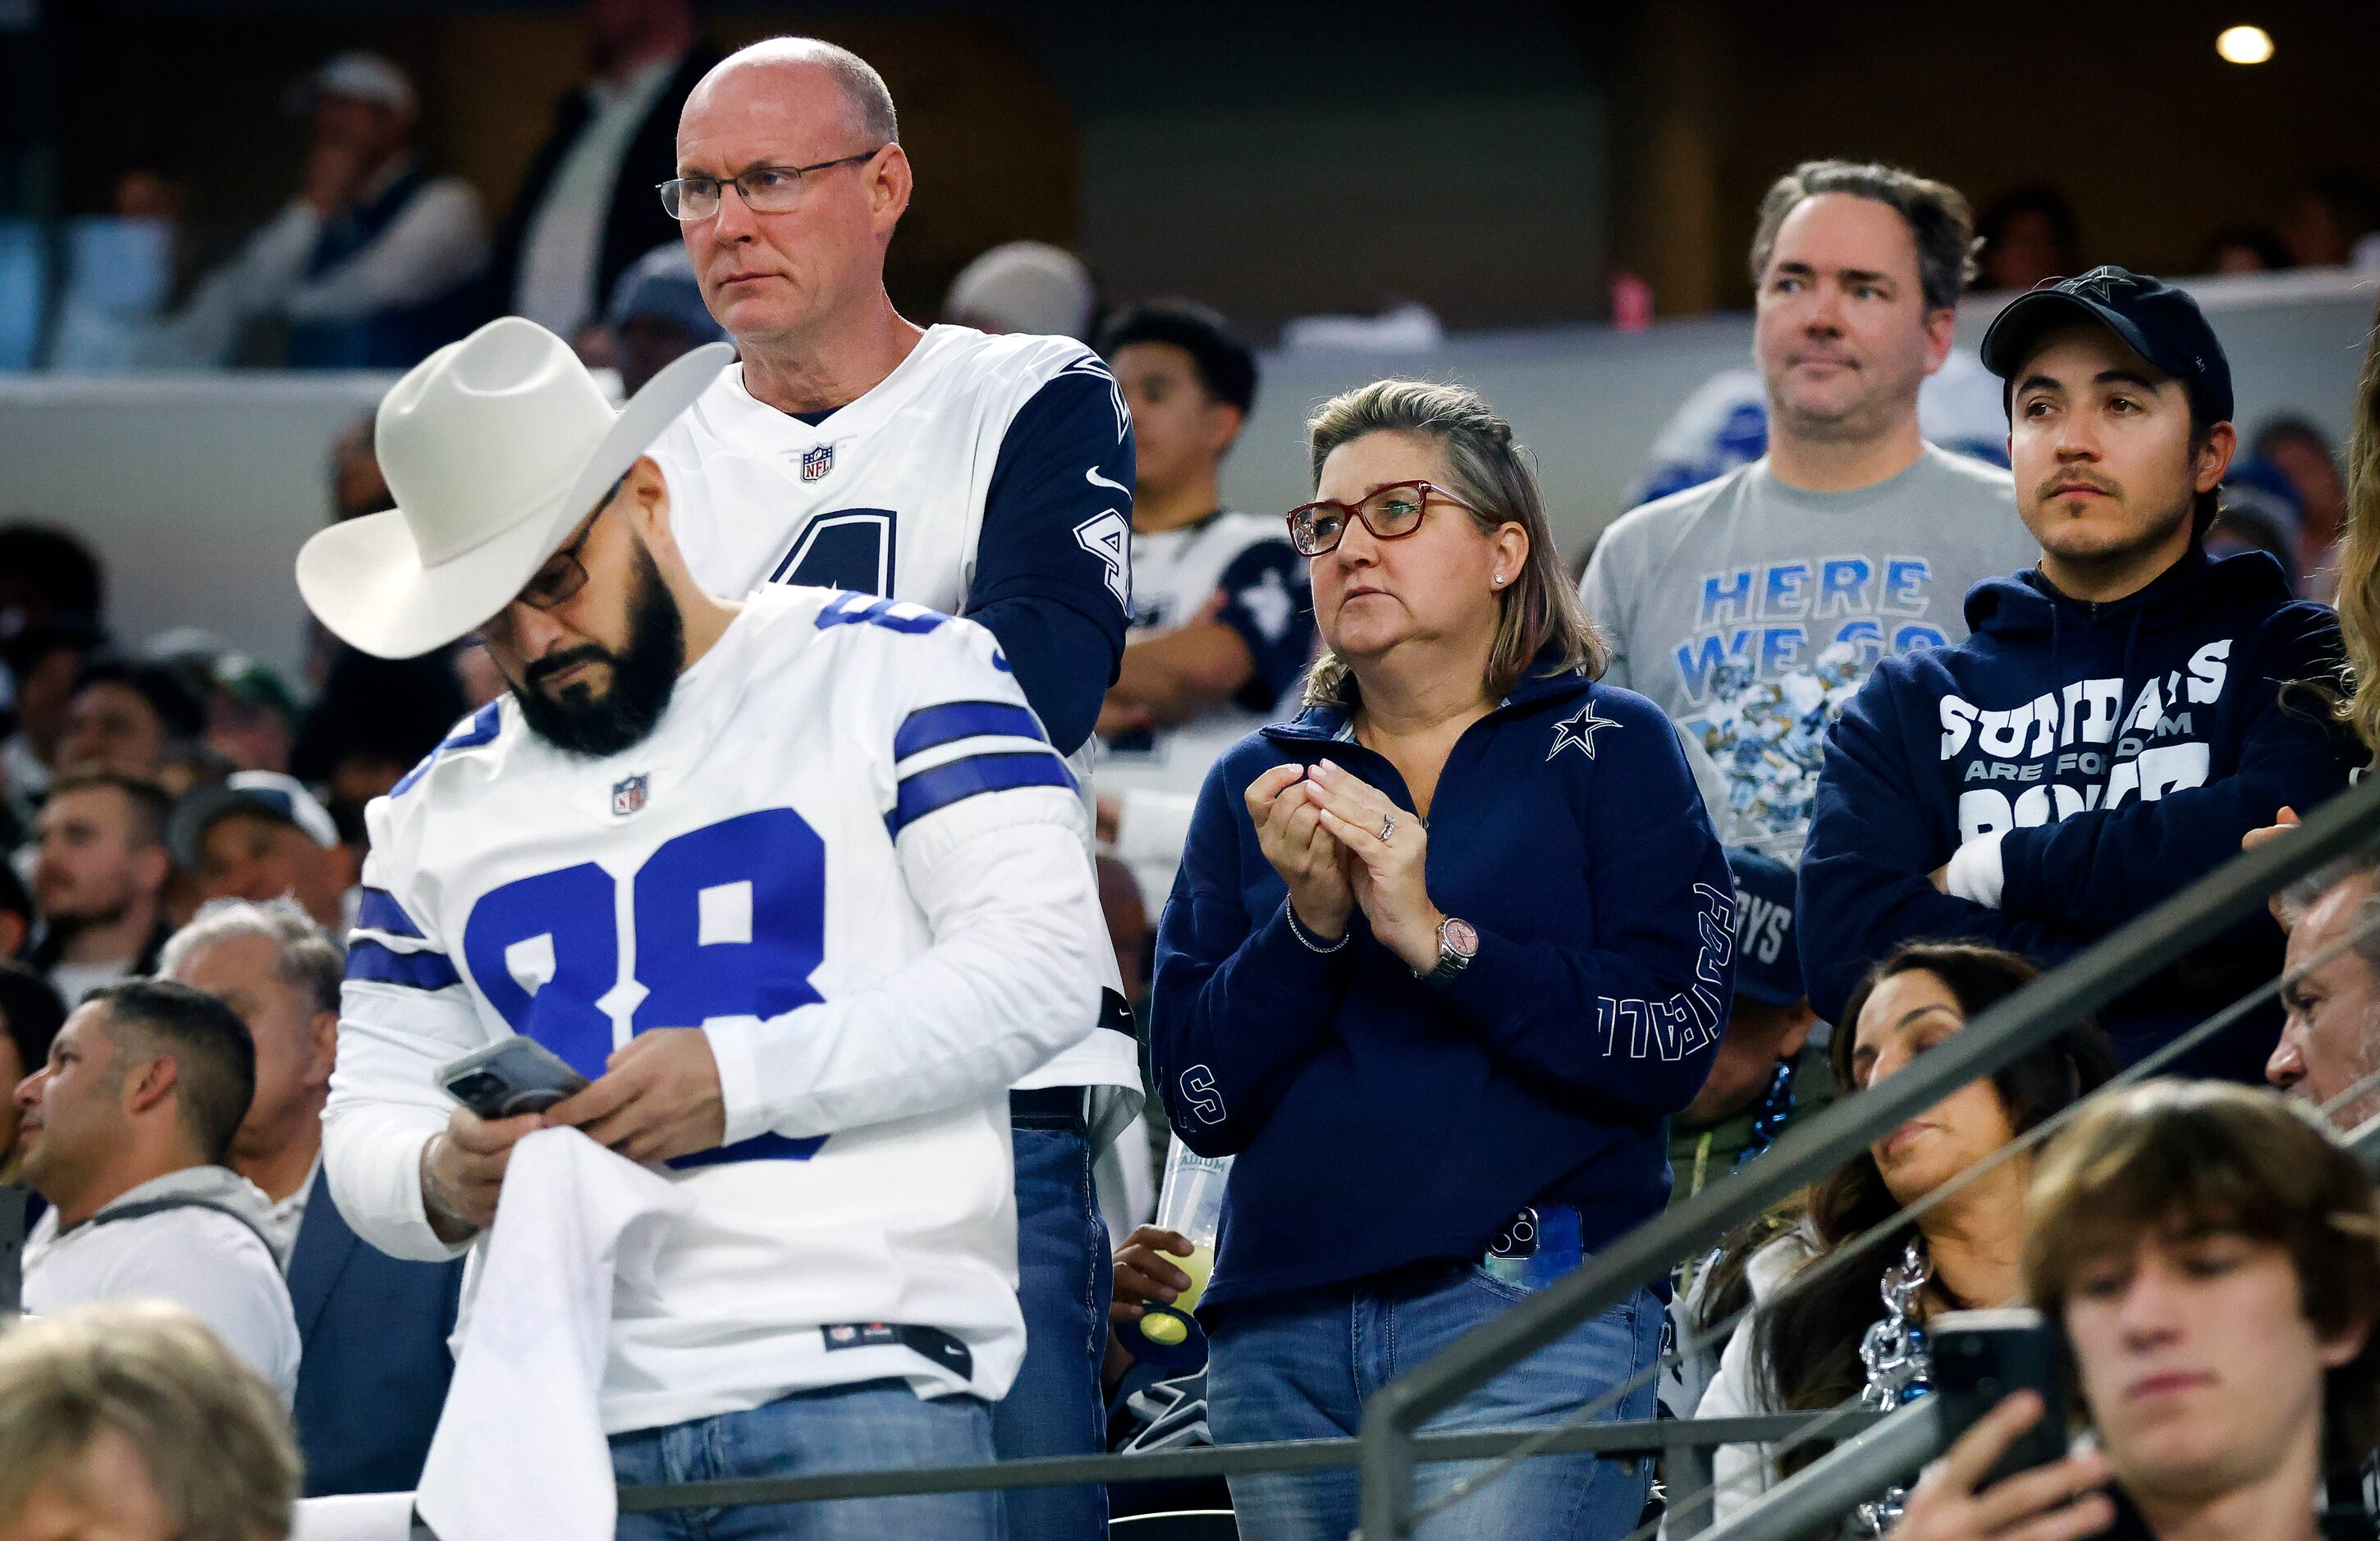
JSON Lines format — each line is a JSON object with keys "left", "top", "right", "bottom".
{"left": 1797, "top": 547, "right": 2356, "bottom": 1080}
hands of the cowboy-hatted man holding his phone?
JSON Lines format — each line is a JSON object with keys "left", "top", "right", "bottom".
{"left": 421, "top": 1027, "right": 728, "bottom": 1241}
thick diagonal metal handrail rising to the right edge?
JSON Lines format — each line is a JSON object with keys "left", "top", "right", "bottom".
{"left": 1359, "top": 778, "right": 2380, "bottom": 1541}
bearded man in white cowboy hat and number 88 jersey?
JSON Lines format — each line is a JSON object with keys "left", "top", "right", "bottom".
{"left": 298, "top": 316, "right": 1105, "bottom": 1541}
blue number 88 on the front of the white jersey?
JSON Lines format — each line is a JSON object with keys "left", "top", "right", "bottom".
{"left": 462, "top": 808, "right": 826, "bottom": 1168}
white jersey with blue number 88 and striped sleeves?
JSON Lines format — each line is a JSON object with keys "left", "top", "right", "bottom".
{"left": 323, "top": 588, "right": 1121, "bottom": 1432}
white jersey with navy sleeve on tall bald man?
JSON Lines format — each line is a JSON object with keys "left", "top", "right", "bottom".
{"left": 650, "top": 326, "right": 1140, "bottom": 1108}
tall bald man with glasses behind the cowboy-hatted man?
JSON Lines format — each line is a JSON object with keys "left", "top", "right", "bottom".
{"left": 652, "top": 38, "right": 1140, "bottom": 1541}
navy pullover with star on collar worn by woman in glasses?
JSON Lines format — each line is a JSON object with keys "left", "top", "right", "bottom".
{"left": 1150, "top": 652, "right": 1735, "bottom": 1306}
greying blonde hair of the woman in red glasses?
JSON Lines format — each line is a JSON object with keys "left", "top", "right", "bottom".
{"left": 1304, "top": 381, "right": 1609, "bottom": 706}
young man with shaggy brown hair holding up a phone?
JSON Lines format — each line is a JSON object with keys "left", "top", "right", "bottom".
{"left": 1890, "top": 1082, "right": 2380, "bottom": 1541}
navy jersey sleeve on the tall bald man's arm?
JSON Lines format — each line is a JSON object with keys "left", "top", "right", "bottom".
{"left": 966, "top": 354, "right": 1133, "bottom": 754}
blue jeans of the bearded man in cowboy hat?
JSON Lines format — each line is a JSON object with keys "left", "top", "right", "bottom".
{"left": 611, "top": 1379, "right": 1007, "bottom": 1541}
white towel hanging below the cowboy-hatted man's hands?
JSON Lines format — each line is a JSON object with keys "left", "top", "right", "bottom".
{"left": 417, "top": 1130, "right": 683, "bottom": 1541}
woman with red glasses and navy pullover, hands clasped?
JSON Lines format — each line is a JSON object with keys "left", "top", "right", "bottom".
{"left": 1150, "top": 381, "right": 1735, "bottom": 1541}
